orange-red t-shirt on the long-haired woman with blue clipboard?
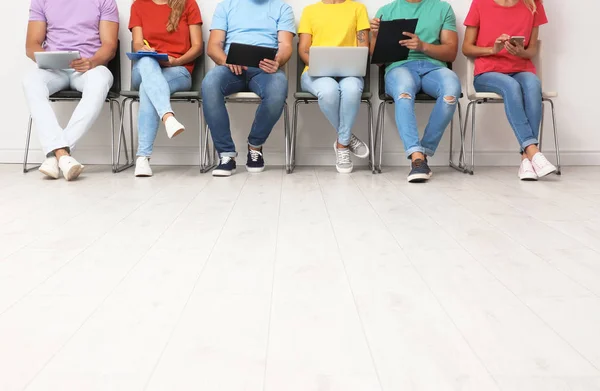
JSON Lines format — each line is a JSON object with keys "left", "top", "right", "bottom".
{"left": 129, "top": 0, "right": 202, "bottom": 74}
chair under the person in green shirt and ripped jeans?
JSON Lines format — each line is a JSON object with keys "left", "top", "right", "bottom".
{"left": 376, "top": 63, "right": 467, "bottom": 173}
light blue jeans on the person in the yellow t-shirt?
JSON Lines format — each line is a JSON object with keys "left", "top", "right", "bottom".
{"left": 301, "top": 72, "right": 365, "bottom": 145}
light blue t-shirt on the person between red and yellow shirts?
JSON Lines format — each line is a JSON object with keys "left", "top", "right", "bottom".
{"left": 210, "top": 0, "right": 296, "bottom": 53}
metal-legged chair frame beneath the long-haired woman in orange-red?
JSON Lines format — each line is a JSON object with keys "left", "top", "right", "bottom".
{"left": 117, "top": 43, "right": 217, "bottom": 174}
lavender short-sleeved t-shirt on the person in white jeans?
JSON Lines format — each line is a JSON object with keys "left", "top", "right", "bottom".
{"left": 29, "top": 0, "right": 119, "bottom": 58}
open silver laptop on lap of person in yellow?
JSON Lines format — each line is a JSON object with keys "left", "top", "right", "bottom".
{"left": 308, "top": 46, "right": 369, "bottom": 77}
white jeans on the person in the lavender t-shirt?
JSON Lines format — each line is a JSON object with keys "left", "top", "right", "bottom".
{"left": 23, "top": 66, "right": 113, "bottom": 156}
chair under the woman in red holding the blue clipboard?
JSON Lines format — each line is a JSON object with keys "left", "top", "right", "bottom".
{"left": 118, "top": 44, "right": 216, "bottom": 173}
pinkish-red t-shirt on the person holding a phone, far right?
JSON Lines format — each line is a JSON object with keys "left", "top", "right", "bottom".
{"left": 465, "top": 0, "right": 548, "bottom": 75}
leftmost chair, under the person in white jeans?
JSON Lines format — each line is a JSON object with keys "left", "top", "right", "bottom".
{"left": 23, "top": 43, "right": 123, "bottom": 173}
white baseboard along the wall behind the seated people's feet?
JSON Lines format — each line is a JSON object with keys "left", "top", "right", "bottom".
{"left": 0, "top": 146, "right": 600, "bottom": 166}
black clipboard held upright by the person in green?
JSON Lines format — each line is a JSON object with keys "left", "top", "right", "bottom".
{"left": 371, "top": 19, "right": 419, "bottom": 64}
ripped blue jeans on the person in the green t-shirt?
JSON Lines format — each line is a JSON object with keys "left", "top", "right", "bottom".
{"left": 385, "top": 60, "right": 460, "bottom": 158}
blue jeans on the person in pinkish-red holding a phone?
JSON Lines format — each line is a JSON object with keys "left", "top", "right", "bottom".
{"left": 473, "top": 72, "right": 542, "bottom": 152}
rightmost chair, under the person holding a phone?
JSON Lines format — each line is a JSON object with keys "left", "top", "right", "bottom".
{"left": 464, "top": 41, "right": 561, "bottom": 175}
